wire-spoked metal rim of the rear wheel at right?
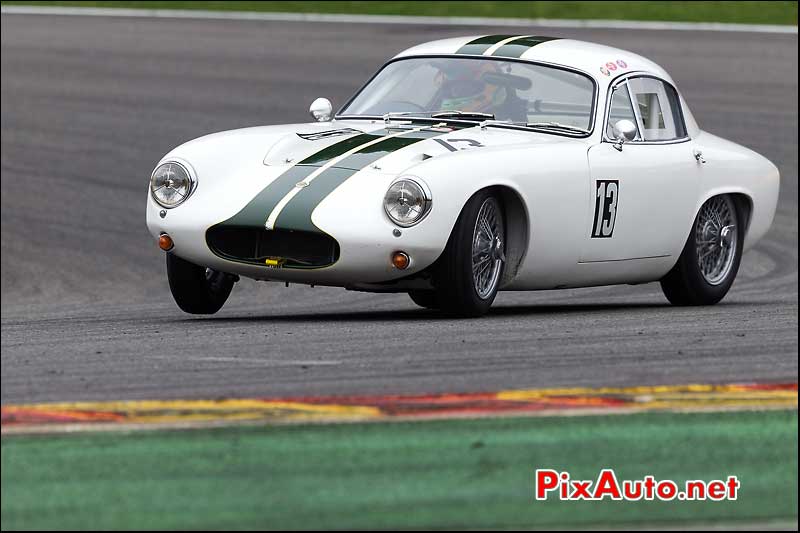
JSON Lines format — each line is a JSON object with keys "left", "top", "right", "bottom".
{"left": 694, "top": 196, "right": 739, "bottom": 285}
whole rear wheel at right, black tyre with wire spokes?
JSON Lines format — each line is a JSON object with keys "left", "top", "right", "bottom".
{"left": 661, "top": 195, "right": 744, "bottom": 305}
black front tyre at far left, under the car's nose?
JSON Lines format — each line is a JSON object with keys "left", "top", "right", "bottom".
{"left": 166, "top": 252, "right": 238, "bottom": 315}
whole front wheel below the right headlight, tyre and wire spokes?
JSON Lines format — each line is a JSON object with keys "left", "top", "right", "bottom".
{"left": 434, "top": 190, "right": 505, "bottom": 317}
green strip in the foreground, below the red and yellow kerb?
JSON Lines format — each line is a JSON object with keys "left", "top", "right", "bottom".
{"left": 2, "top": 411, "right": 797, "bottom": 529}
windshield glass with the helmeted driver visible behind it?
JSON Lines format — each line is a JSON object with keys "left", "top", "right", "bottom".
{"left": 340, "top": 57, "right": 594, "bottom": 132}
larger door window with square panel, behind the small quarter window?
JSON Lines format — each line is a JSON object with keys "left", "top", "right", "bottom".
{"left": 627, "top": 78, "right": 686, "bottom": 141}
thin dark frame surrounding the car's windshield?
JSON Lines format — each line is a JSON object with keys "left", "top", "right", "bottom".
{"left": 334, "top": 54, "right": 599, "bottom": 139}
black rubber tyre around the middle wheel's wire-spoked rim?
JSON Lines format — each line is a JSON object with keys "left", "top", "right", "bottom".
{"left": 434, "top": 190, "right": 505, "bottom": 317}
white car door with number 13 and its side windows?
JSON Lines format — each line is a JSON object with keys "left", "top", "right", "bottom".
{"left": 581, "top": 76, "right": 700, "bottom": 263}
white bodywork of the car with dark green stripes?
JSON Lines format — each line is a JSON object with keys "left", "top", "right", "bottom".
{"left": 147, "top": 36, "right": 779, "bottom": 290}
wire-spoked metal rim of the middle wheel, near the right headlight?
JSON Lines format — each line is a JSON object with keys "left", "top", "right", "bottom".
{"left": 472, "top": 198, "right": 505, "bottom": 300}
